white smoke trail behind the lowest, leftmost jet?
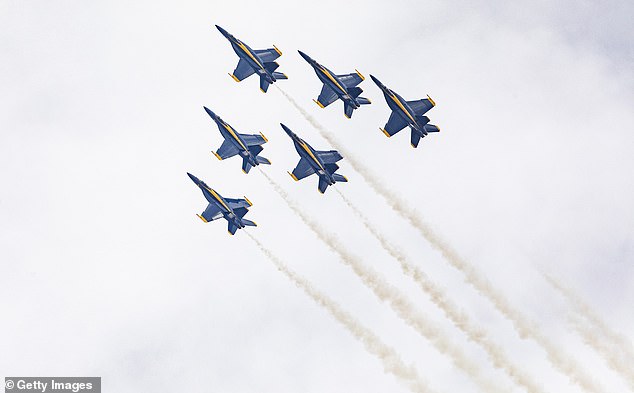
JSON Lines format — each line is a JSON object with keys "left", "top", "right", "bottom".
{"left": 245, "top": 231, "right": 433, "bottom": 393}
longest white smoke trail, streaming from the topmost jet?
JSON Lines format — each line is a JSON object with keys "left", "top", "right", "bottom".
{"left": 277, "top": 86, "right": 605, "bottom": 393}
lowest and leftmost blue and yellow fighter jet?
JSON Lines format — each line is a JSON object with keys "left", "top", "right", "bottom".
{"left": 187, "top": 172, "right": 257, "bottom": 235}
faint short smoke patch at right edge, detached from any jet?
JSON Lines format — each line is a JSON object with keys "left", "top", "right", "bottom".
{"left": 542, "top": 272, "right": 634, "bottom": 391}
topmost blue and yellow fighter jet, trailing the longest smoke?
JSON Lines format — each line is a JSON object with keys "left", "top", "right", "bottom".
{"left": 216, "top": 25, "right": 288, "bottom": 93}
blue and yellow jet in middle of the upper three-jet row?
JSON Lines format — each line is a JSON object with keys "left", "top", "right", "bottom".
{"left": 298, "top": 50, "right": 370, "bottom": 119}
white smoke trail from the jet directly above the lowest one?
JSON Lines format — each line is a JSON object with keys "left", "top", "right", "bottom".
{"left": 260, "top": 171, "right": 500, "bottom": 392}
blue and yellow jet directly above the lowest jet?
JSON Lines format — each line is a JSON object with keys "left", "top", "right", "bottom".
{"left": 203, "top": 106, "right": 271, "bottom": 173}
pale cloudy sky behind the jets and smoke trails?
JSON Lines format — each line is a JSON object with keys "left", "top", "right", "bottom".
{"left": 0, "top": 0, "right": 634, "bottom": 392}
